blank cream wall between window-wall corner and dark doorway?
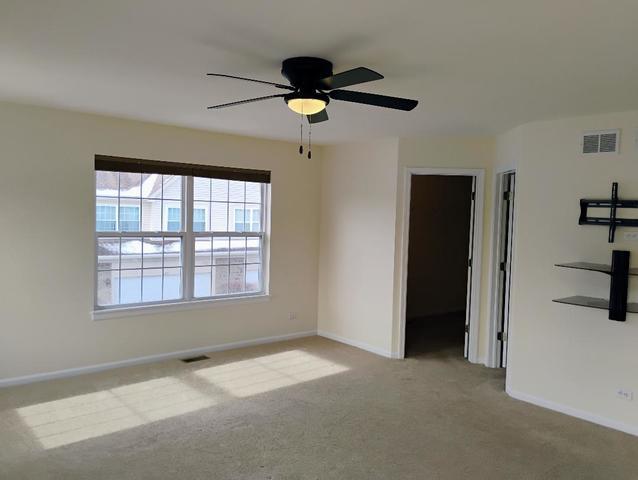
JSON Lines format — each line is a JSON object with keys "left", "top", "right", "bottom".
{"left": 318, "top": 139, "right": 398, "bottom": 356}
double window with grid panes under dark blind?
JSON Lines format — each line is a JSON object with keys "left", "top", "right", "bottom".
{"left": 95, "top": 156, "right": 269, "bottom": 309}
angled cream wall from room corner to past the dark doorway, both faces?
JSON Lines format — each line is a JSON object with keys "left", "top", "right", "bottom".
{"left": 318, "top": 137, "right": 495, "bottom": 361}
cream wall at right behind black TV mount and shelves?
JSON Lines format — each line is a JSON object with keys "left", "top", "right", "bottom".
{"left": 498, "top": 112, "right": 638, "bottom": 434}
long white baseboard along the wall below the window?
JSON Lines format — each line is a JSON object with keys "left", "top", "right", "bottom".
{"left": 0, "top": 330, "right": 317, "bottom": 388}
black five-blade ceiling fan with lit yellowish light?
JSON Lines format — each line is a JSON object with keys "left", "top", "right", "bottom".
{"left": 208, "top": 57, "right": 418, "bottom": 124}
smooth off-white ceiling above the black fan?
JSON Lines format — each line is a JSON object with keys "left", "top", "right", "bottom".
{"left": 0, "top": 0, "right": 638, "bottom": 143}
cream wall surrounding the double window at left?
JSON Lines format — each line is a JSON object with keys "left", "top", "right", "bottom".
{"left": 0, "top": 103, "right": 321, "bottom": 380}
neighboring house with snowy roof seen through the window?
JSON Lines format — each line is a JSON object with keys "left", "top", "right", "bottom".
{"left": 95, "top": 172, "right": 261, "bottom": 305}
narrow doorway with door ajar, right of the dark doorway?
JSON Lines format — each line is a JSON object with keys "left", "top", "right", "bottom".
{"left": 496, "top": 172, "right": 516, "bottom": 368}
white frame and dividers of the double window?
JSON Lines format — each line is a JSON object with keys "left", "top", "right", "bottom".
{"left": 92, "top": 175, "right": 270, "bottom": 320}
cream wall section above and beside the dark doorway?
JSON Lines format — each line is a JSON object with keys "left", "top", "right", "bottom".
{"left": 393, "top": 137, "right": 496, "bottom": 363}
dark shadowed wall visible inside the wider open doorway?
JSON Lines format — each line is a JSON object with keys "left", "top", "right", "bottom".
{"left": 406, "top": 175, "right": 472, "bottom": 320}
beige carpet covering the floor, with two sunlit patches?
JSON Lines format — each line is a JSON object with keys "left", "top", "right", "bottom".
{"left": 0, "top": 337, "right": 638, "bottom": 480}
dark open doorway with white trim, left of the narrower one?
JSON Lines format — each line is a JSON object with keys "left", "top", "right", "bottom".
{"left": 403, "top": 169, "right": 483, "bottom": 358}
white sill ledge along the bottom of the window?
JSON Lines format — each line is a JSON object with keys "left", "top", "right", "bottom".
{"left": 91, "top": 294, "right": 270, "bottom": 320}
